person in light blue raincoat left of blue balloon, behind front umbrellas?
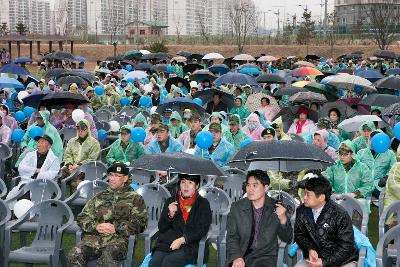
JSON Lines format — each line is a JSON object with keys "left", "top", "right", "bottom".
{"left": 194, "top": 123, "right": 235, "bottom": 167}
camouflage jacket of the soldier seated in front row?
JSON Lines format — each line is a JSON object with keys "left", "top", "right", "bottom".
{"left": 77, "top": 182, "right": 147, "bottom": 246}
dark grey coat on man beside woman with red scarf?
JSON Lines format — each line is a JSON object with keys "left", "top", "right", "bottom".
{"left": 226, "top": 196, "right": 293, "bottom": 267}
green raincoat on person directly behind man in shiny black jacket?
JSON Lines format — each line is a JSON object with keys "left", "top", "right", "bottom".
{"left": 325, "top": 159, "right": 374, "bottom": 197}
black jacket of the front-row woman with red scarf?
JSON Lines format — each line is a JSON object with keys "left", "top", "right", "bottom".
{"left": 154, "top": 195, "right": 211, "bottom": 262}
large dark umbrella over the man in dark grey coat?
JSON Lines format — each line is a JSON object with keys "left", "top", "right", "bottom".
{"left": 228, "top": 141, "right": 335, "bottom": 172}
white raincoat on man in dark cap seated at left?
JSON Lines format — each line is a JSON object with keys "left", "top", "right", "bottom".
{"left": 18, "top": 149, "right": 60, "bottom": 183}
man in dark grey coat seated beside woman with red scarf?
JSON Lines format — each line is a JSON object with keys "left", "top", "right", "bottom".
{"left": 226, "top": 170, "right": 293, "bottom": 267}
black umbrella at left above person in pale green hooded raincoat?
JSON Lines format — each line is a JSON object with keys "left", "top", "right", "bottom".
{"left": 40, "top": 92, "right": 90, "bottom": 109}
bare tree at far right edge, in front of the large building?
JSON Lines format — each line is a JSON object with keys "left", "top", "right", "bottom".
{"left": 368, "top": 4, "right": 400, "bottom": 50}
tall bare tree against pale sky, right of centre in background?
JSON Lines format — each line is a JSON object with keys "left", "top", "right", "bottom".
{"left": 229, "top": 0, "right": 256, "bottom": 53}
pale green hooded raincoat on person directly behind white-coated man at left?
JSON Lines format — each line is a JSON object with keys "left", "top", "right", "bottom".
{"left": 16, "top": 110, "right": 64, "bottom": 166}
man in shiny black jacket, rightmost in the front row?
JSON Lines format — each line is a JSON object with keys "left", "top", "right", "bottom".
{"left": 294, "top": 175, "right": 358, "bottom": 267}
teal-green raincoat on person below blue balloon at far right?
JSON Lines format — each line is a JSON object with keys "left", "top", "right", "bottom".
{"left": 357, "top": 148, "right": 396, "bottom": 188}
